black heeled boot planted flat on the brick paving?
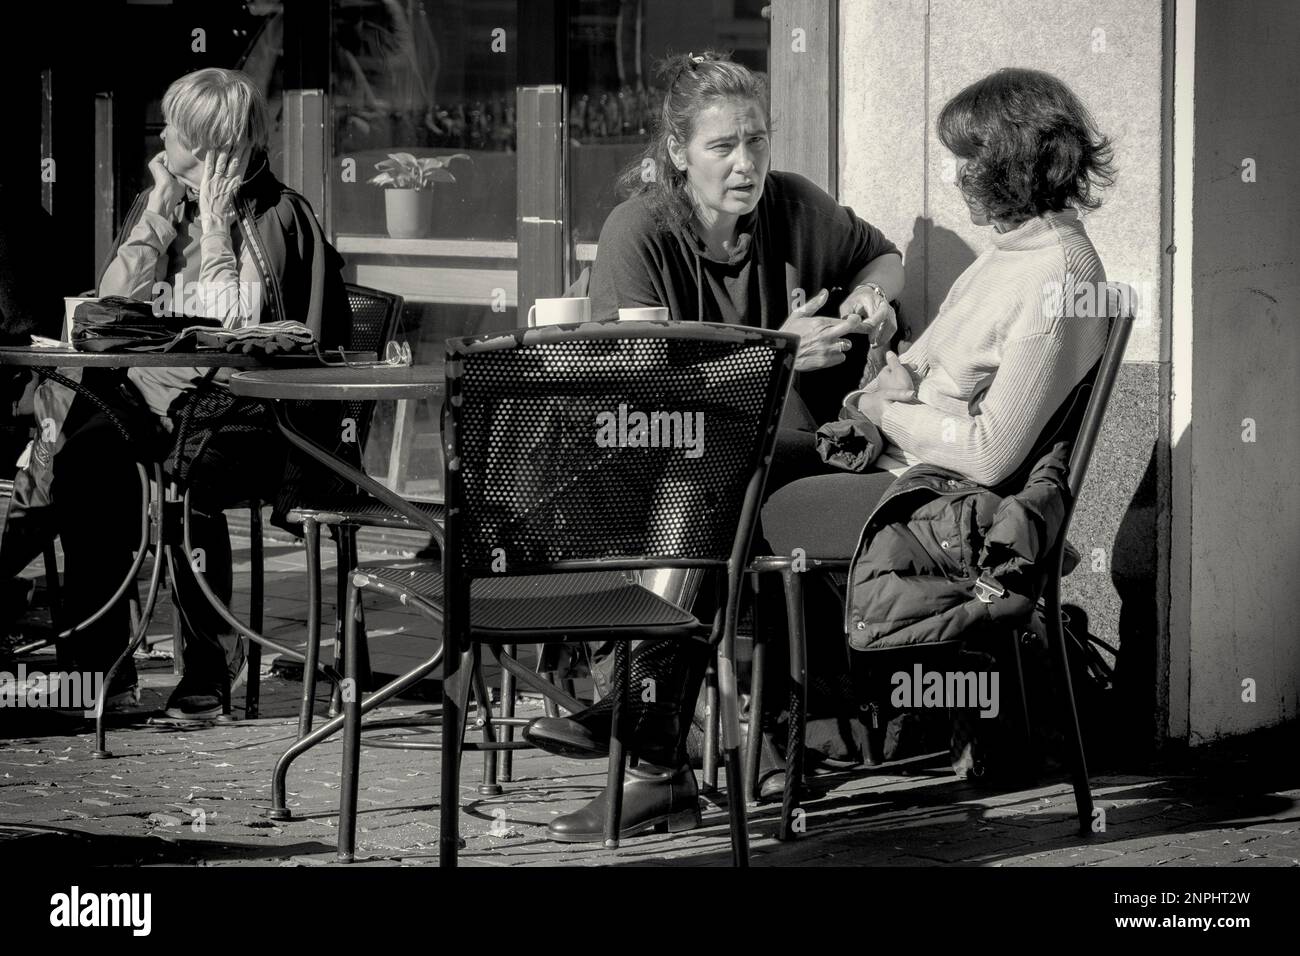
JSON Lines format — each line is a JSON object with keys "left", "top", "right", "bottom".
{"left": 546, "top": 763, "right": 701, "bottom": 843}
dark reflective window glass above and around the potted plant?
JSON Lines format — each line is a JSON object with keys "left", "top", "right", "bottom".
{"left": 330, "top": 0, "right": 517, "bottom": 239}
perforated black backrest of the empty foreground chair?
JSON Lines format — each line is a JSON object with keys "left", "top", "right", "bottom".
{"left": 443, "top": 323, "right": 798, "bottom": 578}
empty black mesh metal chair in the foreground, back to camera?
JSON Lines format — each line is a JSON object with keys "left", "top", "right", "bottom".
{"left": 339, "top": 323, "right": 798, "bottom": 866}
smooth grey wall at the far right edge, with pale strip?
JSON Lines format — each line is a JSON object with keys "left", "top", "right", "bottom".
{"left": 1170, "top": 0, "right": 1300, "bottom": 744}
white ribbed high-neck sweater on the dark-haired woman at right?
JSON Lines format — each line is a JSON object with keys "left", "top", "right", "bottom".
{"left": 845, "top": 209, "right": 1108, "bottom": 485}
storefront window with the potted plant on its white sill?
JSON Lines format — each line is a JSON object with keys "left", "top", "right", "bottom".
{"left": 328, "top": 0, "right": 520, "bottom": 498}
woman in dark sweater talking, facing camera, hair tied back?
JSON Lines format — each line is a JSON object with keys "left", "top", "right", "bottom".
{"left": 525, "top": 53, "right": 904, "bottom": 842}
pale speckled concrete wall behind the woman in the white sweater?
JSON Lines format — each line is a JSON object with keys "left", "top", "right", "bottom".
{"left": 840, "top": 0, "right": 1170, "bottom": 743}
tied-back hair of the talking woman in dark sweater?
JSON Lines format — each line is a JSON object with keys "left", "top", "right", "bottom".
{"left": 619, "top": 49, "right": 772, "bottom": 226}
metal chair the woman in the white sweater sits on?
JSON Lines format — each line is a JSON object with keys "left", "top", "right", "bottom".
{"left": 748, "top": 294, "right": 1134, "bottom": 840}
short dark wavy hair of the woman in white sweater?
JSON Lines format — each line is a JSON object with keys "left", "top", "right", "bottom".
{"left": 937, "top": 68, "right": 1115, "bottom": 222}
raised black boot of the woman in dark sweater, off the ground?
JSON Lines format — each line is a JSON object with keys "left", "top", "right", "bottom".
{"left": 524, "top": 641, "right": 709, "bottom": 767}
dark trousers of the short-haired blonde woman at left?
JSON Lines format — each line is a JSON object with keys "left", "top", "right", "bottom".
{"left": 51, "top": 377, "right": 286, "bottom": 687}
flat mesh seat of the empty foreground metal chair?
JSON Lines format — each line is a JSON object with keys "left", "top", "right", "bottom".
{"left": 352, "top": 563, "right": 705, "bottom": 643}
